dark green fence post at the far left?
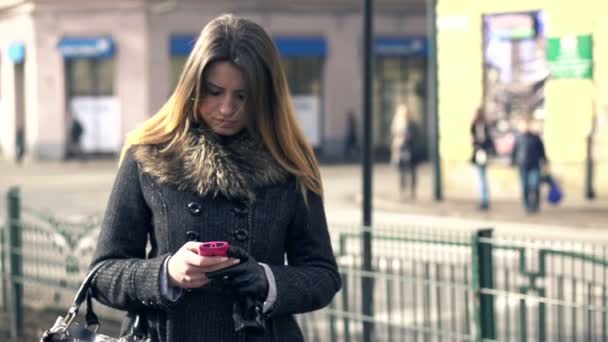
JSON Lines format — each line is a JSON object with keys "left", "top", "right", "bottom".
{"left": 6, "top": 187, "right": 23, "bottom": 338}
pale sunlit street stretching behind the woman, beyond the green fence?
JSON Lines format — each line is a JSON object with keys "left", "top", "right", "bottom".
{"left": 0, "top": 160, "right": 608, "bottom": 241}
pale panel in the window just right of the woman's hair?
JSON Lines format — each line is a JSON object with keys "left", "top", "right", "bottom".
{"left": 293, "top": 95, "right": 321, "bottom": 147}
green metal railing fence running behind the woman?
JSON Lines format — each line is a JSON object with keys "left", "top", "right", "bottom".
{"left": 0, "top": 190, "right": 608, "bottom": 342}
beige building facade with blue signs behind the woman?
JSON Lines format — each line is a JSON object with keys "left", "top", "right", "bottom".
{"left": 0, "top": 0, "right": 426, "bottom": 160}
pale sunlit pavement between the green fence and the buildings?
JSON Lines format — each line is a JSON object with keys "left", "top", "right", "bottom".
{"left": 0, "top": 160, "right": 608, "bottom": 229}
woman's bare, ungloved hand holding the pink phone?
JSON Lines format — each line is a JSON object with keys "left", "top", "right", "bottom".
{"left": 167, "top": 241, "right": 238, "bottom": 289}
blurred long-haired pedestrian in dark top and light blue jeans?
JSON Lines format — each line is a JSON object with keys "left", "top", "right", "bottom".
{"left": 470, "top": 107, "right": 494, "bottom": 210}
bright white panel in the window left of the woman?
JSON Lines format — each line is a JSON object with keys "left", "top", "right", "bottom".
{"left": 70, "top": 96, "right": 122, "bottom": 153}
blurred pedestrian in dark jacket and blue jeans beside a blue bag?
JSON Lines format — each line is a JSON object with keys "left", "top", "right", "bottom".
{"left": 512, "top": 118, "right": 548, "bottom": 213}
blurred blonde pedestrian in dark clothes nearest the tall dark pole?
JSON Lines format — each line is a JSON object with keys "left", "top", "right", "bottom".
{"left": 391, "top": 104, "right": 418, "bottom": 199}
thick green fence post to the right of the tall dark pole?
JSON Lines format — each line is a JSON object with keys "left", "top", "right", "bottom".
{"left": 473, "top": 228, "right": 496, "bottom": 341}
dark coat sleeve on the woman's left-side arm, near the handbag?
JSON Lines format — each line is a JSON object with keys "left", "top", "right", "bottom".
{"left": 92, "top": 151, "right": 177, "bottom": 311}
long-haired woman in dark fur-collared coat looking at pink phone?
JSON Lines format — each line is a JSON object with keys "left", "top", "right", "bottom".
{"left": 93, "top": 15, "right": 341, "bottom": 341}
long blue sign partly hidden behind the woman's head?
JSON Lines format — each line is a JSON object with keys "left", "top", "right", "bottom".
{"left": 169, "top": 34, "right": 327, "bottom": 57}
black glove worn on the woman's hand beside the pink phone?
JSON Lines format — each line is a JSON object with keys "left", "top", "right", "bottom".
{"left": 207, "top": 246, "right": 268, "bottom": 301}
